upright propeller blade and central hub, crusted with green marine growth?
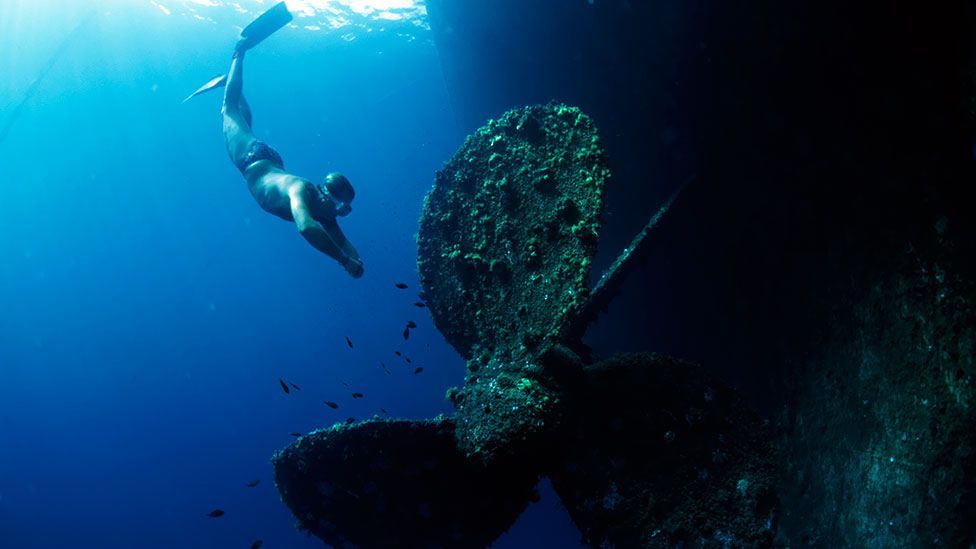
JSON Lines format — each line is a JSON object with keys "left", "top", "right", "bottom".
{"left": 418, "top": 104, "right": 610, "bottom": 460}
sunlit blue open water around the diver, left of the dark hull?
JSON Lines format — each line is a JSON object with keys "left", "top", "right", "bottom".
{"left": 0, "top": 0, "right": 578, "bottom": 549}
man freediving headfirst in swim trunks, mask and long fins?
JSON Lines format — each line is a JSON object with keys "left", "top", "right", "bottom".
{"left": 187, "top": 2, "right": 363, "bottom": 278}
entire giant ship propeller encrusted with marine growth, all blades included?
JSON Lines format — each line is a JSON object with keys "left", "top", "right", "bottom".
{"left": 274, "top": 105, "right": 776, "bottom": 548}
